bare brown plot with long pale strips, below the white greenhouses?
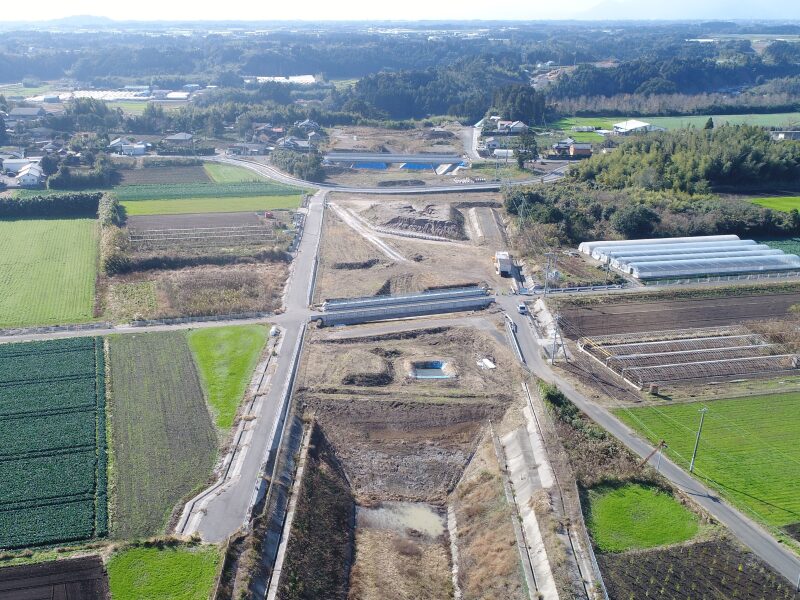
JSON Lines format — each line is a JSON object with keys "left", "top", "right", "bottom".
{"left": 578, "top": 326, "right": 798, "bottom": 389}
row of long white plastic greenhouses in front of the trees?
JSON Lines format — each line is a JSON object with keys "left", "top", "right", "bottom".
{"left": 578, "top": 235, "right": 800, "bottom": 280}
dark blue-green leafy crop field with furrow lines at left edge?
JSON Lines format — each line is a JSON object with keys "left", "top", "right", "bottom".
{"left": 0, "top": 338, "right": 108, "bottom": 548}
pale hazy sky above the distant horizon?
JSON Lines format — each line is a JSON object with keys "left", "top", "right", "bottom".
{"left": 10, "top": 0, "right": 800, "bottom": 21}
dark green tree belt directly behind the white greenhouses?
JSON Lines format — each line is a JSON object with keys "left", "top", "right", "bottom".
{"left": 504, "top": 181, "right": 800, "bottom": 250}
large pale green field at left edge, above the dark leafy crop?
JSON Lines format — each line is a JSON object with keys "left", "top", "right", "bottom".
{"left": 0, "top": 219, "right": 97, "bottom": 327}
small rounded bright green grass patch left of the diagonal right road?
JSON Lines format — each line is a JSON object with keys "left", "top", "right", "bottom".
{"left": 586, "top": 483, "right": 698, "bottom": 552}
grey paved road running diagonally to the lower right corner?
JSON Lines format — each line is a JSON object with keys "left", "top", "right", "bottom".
{"left": 497, "top": 296, "right": 800, "bottom": 583}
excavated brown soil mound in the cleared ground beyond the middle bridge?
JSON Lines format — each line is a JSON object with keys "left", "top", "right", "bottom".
{"left": 362, "top": 202, "right": 467, "bottom": 240}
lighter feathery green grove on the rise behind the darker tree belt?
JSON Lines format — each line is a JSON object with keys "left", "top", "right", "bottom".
{"left": 570, "top": 125, "right": 800, "bottom": 193}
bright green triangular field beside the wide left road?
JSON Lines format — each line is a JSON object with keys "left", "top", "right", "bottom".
{"left": 188, "top": 325, "right": 268, "bottom": 431}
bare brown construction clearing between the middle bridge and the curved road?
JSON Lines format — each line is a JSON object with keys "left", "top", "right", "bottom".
{"left": 314, "top": 193, "right": 508, "bottom": 303}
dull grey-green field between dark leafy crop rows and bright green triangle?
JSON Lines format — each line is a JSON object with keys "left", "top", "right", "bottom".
{"left": 109, "top": 332, "right": 217, "bottom": 538}
